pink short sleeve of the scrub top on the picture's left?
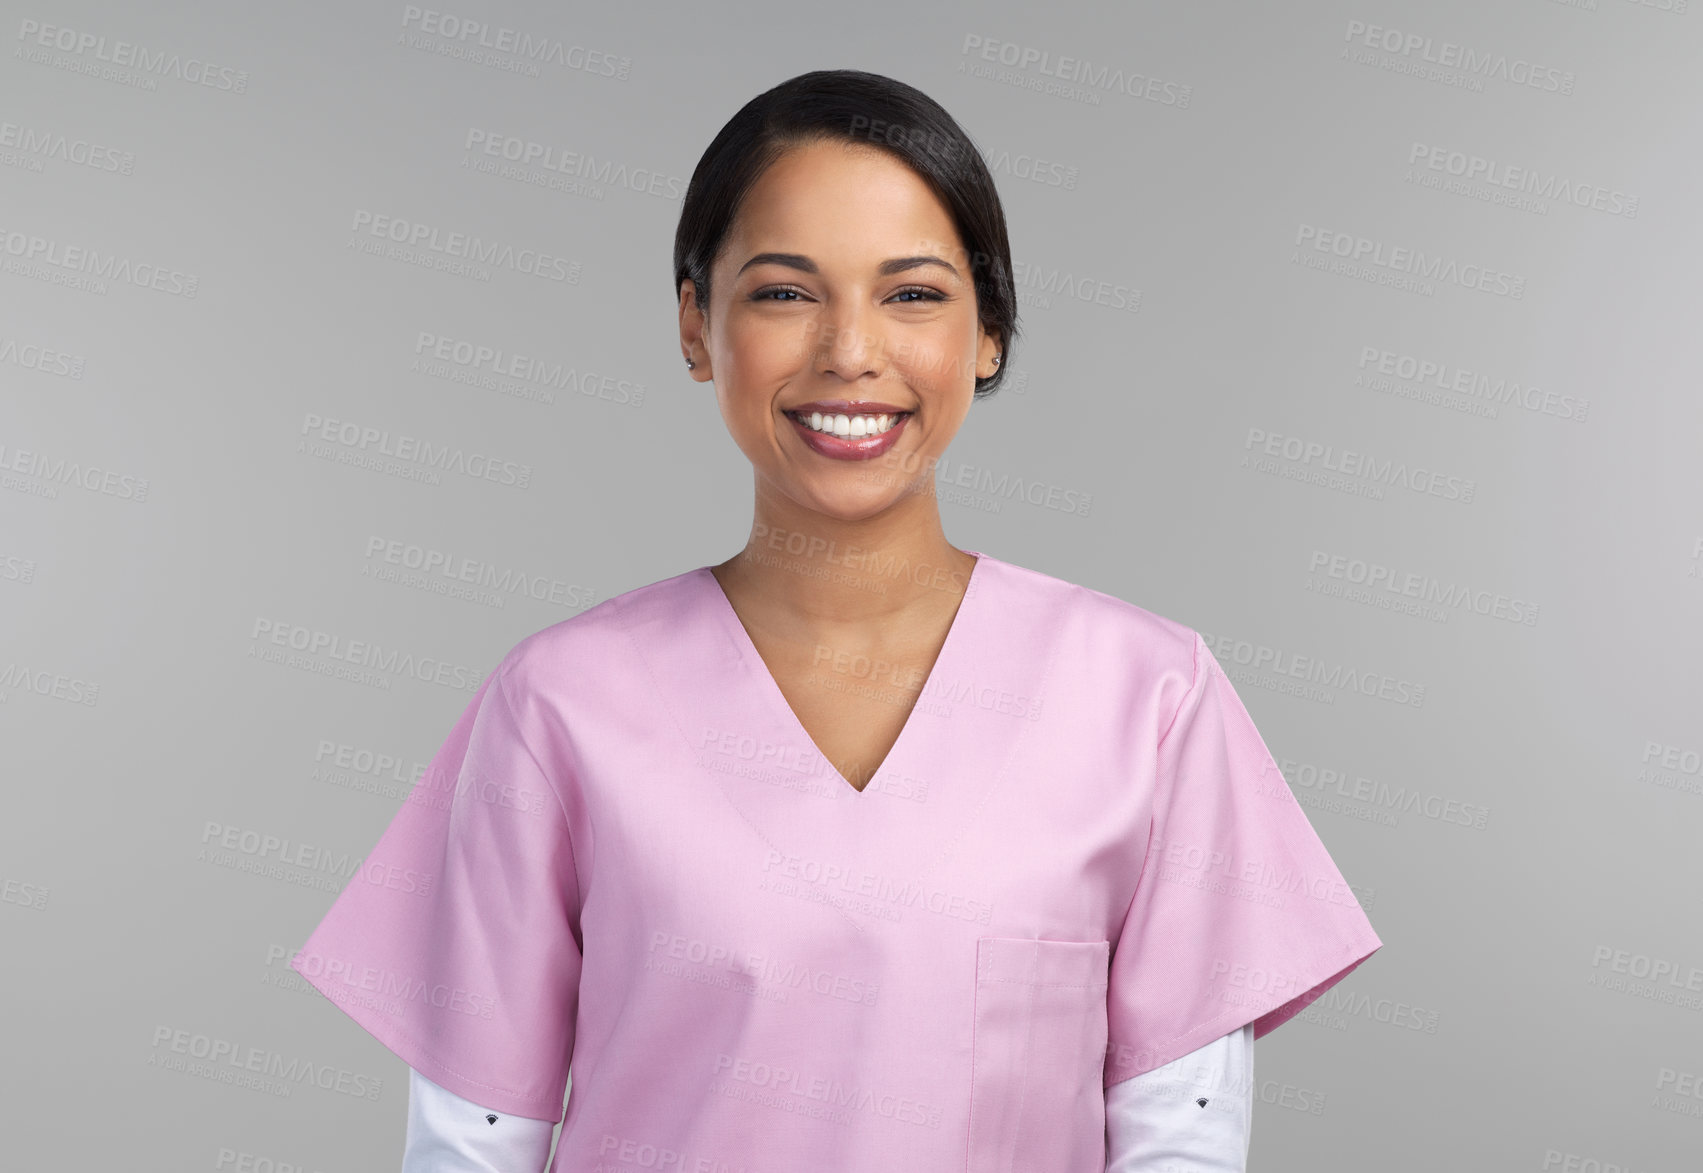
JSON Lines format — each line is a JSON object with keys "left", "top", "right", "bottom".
{"left": 290, "top": 661, "right": 582, "bottom": 1120}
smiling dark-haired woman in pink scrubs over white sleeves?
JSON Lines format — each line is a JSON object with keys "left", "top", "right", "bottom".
{"left": 293, "top": 70, "right": 1381, "bottom": 1173}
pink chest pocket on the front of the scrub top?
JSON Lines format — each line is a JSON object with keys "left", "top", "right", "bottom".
{"left": 966, "top": 936, "right": 1112, "bottom": 1173}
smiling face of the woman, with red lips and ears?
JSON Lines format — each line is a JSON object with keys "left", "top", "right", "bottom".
{"left": 676, "top": 138, "right": 1013, "bottom": 517}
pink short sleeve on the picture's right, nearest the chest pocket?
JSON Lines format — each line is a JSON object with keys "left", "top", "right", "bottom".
{"left": 1105, "top": 633, "right": 1383, "bottom": 1086}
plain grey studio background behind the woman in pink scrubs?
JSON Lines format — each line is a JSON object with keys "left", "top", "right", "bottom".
{"left": 0, "top": 0, "right": 1703, "bottom": 1173}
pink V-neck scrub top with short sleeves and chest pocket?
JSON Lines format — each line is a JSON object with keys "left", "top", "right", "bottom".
{"left": 291, "top": 552, "right": 1381, "bottom": 1173}
